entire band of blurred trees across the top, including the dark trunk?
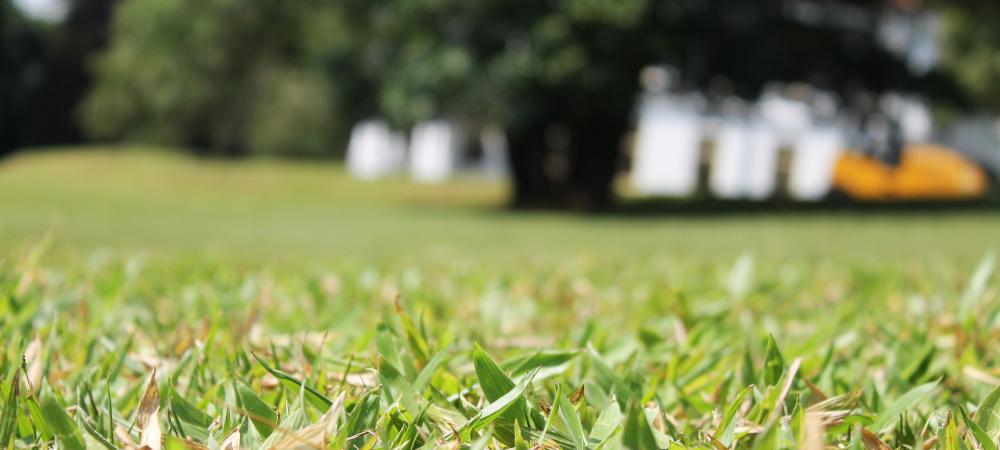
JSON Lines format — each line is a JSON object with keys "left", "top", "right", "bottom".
{"left": 0, "top": 0, "right": 1000, "bottom": 205}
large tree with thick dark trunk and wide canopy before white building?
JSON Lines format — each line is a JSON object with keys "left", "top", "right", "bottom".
{"left": 359, "top": 0, "right": 960, "bottom": 208}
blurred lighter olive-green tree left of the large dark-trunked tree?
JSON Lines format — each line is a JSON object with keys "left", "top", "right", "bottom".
{"left": 82, "top": 0, "right": 364, "bottom": 156}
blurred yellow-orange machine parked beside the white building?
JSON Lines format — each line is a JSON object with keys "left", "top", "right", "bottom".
{"left": 833, "top": 144, "right": 989, "bottom": 201}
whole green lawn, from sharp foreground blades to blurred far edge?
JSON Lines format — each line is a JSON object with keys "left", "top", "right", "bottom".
{"left": 0, "top": 151, "right": 1000, "bottom": 450}
